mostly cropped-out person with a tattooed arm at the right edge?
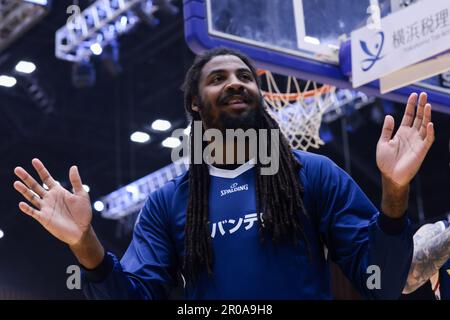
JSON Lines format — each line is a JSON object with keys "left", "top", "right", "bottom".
{"left": 403, "top": 220, "right": 450, "bottom": 300}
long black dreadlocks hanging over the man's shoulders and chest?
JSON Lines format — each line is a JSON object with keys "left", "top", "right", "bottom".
{"left": 182, "top": 47, "right": 310, "bottom": 280}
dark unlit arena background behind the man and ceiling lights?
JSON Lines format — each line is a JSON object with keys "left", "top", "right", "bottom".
{"left": 0, "top": 0, "right": 450, "bottom": 299}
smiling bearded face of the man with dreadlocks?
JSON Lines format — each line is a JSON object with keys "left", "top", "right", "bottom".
{"left": 192, "top": 55, "right": 262, "bottom": 130}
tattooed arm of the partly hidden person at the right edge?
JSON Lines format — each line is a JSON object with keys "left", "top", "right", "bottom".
{"left": 403, "top": 222, "right": 450, "bottom": 294}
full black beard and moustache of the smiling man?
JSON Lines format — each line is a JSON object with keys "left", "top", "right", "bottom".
{"left": 199, "top": 92, "right": 264, "bottom": 133}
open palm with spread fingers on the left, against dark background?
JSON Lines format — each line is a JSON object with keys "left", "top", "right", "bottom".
{"left": 14, "top": 159, "right": 92, "bottom": 245}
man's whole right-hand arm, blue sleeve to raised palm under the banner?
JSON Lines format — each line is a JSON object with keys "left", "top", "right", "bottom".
{"left": 323, "top": 93, "right": 434, "bottom": 299}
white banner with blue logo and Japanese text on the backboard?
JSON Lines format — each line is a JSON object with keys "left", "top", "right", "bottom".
{"left": 351, "top": 0, "right": 450, "bottom": 88}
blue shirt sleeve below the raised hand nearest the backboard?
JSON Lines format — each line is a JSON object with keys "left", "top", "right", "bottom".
{"left": 314, "top": 157, "right": 413, "bottom": 299}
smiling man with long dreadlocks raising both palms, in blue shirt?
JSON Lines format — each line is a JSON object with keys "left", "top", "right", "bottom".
{"left": 14, "top": 48, "right": 434, "bottom": 299}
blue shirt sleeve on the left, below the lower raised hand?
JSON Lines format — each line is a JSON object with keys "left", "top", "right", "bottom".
{"left": 83, "top": 190, "right": 177, "bottom": 300}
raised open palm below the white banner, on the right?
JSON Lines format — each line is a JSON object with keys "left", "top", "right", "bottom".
{"left": 376, "top": 93, "right": 434, "bottom": 186}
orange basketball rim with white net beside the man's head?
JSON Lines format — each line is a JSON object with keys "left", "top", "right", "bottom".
{"left": 258, "top": 70, "right": 337, "bottom": 150}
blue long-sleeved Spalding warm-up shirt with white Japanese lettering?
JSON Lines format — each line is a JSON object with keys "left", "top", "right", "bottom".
{"left": 83, "top": 151, "right": 413, "bottom": 299}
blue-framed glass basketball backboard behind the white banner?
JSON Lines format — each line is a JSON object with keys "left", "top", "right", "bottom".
{"left": 184, "top": 0, "right": 450, "bottom": 113}
